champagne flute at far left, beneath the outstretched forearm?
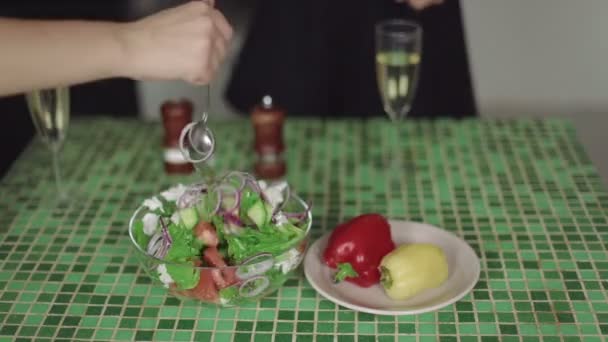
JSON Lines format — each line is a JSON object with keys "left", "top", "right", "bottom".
{"left": 26, "top": 87, "right": 70, "bottom": 203}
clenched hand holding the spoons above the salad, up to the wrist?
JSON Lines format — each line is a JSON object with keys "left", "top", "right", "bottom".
{"left": 119, "top": 1, "right": 232, "bottom": 85}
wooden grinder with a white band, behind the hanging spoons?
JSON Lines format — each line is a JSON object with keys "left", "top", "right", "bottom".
{"left": 161, "top": 99, "right": 194, "bottom": 174}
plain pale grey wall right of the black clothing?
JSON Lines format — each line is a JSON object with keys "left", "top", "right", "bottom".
{"left": 460, "top": 0, "right": 608, "bottom": 117}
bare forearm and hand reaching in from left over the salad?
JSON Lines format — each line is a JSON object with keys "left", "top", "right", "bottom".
{"left": 0, "top": 1, "right": 232, "bottom": 95}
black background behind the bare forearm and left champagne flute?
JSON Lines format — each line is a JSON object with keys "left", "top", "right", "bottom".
{"left": 0, "top": 0, "right": 138, "bottom": 176}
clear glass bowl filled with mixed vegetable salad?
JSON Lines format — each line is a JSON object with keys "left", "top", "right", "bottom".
{"left": 129, "top": 172, "right": 312, "bottom": 306}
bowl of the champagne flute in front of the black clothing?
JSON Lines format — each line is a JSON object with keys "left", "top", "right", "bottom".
{"left": 375, "top": 19, "right": 422, "bottom": 122}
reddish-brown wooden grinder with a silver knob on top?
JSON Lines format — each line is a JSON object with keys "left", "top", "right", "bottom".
{"left": 251, "top": 95, "right": 287, "bottom": 180}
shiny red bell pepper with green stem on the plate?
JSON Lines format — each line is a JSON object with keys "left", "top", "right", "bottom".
{"left": 323, "top": 214, "right": 395, "bottom": 287}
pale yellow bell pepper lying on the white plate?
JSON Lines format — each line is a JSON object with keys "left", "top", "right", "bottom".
{"left": 379, "top": 243, "right": 448, "bottom": 300}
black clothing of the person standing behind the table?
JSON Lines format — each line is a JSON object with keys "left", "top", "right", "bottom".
{"left": 226, "top": 0, "right": 476, "bottom": 117}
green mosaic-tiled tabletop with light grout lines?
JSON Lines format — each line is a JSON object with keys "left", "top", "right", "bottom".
{"left": 0, "top": 118, "right": 608, "bottom": 342}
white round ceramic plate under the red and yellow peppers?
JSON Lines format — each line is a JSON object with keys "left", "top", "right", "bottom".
{"left": 304, "top": 221, "right": 480, "bottom": 315}
